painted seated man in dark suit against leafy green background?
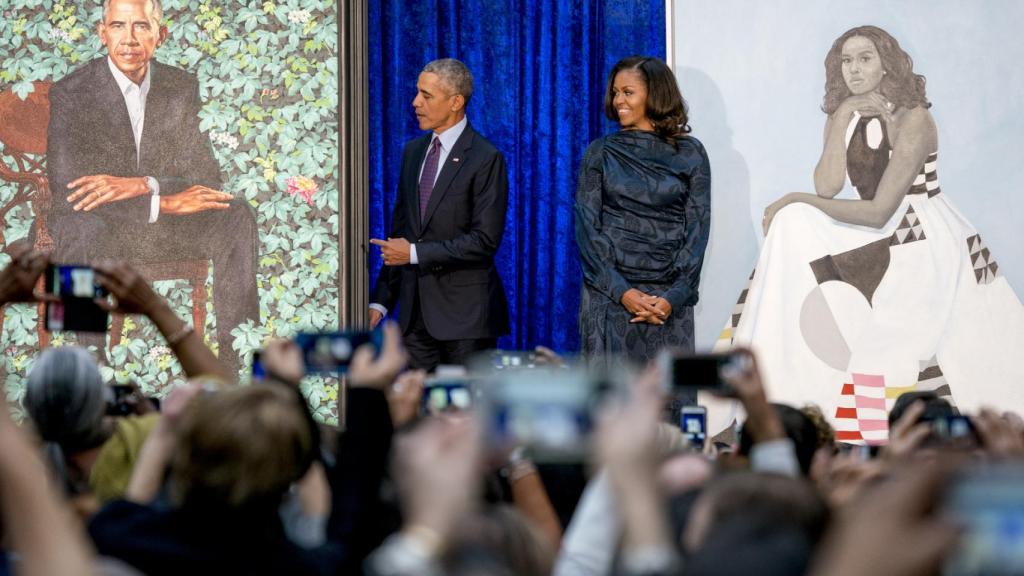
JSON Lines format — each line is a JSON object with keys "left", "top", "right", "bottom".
{"left": 47, "top": 0, "right": 259, "bottom": 369}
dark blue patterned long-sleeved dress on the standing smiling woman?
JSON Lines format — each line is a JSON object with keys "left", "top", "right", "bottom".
{"left": 575, "top": 130, "right": 711, "bottom": 363}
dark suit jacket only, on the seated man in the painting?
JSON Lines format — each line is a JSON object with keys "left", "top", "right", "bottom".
{"left": 46, "top": 56, "right": 221, "bottom": 228}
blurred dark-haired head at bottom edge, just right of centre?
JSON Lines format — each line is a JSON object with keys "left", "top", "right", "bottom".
{"left": 443, "top": 505, "right": 554, "bottom": 576}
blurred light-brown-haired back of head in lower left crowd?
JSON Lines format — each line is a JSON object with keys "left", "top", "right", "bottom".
{"left": 171, "top": 385, "right": 317, "bottom": 511}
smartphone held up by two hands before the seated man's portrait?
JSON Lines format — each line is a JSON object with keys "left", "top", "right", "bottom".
{"left": 44, "top": 264, "right": 110, "bottom": 332}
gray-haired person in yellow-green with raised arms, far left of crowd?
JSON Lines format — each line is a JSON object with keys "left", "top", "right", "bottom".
{"left": 0, "top": 245, "right": 228, "bottom": 517}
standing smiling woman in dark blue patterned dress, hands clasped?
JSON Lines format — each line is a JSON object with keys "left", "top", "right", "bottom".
{"left": 575, "top": 56, "right": 711, "bottom": 364}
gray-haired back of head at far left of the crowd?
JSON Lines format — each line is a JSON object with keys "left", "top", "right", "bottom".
{"left": 24, "top": 346, "right": 110, "bottom": 493}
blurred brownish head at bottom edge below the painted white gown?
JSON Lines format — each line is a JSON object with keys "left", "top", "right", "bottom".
{"left": 685, "top": 472, "right": 828, "bottom": 574}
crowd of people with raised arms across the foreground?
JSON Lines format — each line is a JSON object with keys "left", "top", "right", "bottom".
{"left": 0, "top": 247, "right": 1024, "bottom": 576}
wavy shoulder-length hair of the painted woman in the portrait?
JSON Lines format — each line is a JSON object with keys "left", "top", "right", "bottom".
{"left": 821, "top": 26, "right": 932, "bottom": 114}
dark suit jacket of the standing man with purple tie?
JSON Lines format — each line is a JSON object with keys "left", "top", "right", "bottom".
{"left": 372, "top": 124, "right": 509, "bottom": 340}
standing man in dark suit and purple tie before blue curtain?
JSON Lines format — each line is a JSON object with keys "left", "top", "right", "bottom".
{"left": 370, "top": 58, "right": 509, "bottom": 370}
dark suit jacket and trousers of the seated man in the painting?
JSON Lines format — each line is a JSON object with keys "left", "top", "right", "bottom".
{"left": 46, "top": 56, "right": 259, "bottom": 368}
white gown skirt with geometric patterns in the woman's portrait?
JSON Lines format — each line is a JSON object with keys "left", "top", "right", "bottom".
{"left": 700, "top": 114, "right": 1024, "bottom": 444}
